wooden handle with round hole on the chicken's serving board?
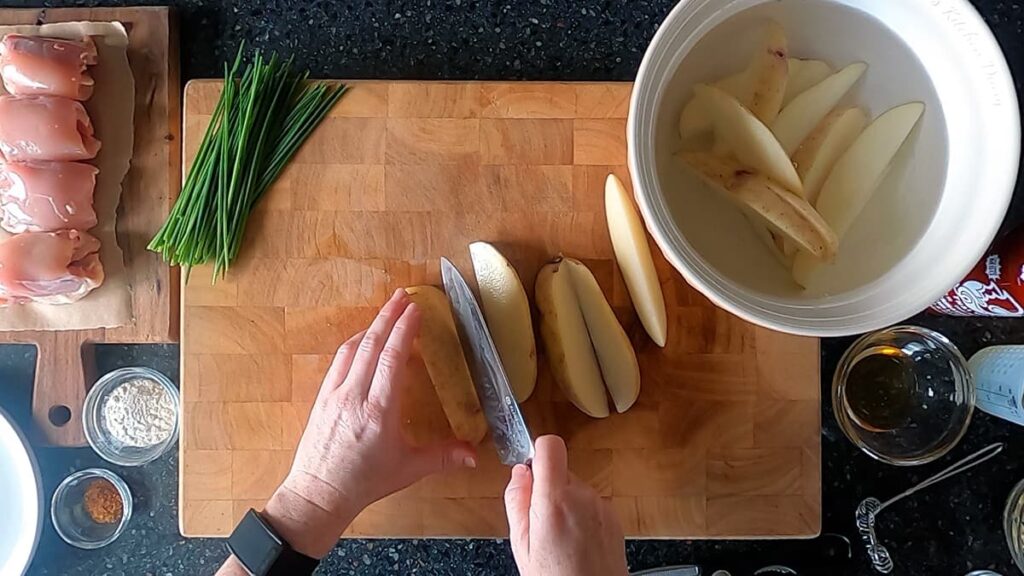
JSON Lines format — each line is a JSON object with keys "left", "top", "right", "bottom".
{"left": 32, "top": 330, "right": 103, "bottom": 446}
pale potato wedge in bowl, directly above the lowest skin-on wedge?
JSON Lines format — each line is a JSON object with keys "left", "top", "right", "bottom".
{"left": 694, "top": 85, "right": 803, "bottom": 195}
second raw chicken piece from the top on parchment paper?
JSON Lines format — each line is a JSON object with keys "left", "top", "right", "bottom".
{"left": 0, "top": 96, "right": 99, "bottom": 162}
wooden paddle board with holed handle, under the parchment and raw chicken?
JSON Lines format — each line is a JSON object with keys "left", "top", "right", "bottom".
{"left": 0, "top": 7, "right": 181, "bottom": 446}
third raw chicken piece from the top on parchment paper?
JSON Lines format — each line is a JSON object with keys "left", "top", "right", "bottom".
{"left": 0, "top": 160, "right": 99, "bottom": 233}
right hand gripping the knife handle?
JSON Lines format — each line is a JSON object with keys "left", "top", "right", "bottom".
{"left": 505, "top": 436, "right": 627, "bottom": 576}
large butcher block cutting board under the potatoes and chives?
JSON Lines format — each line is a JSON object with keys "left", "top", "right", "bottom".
{"left": 180, "top": 81, "right": 821, "bottom": 538}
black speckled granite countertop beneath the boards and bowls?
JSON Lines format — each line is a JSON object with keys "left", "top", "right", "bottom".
{"left": 0, "top": 0, "right": 1024, "bottom": 576}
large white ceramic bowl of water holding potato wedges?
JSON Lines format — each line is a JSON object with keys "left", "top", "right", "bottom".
{"left": 627, "top": 0, "right": 1021, "bottom": 336}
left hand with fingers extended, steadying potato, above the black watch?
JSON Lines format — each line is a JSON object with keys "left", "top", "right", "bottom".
{"left": 263, "top": 290, "right": 476, "bottom": 558}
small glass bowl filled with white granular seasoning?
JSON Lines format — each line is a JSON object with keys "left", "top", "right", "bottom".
{"left": 82, "top": 367, "right": 181, "bottom": 466}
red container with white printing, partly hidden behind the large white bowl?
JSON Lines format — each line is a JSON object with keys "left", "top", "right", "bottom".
{"left": 931, "top": 229, "right": 1024, "bottom": 318}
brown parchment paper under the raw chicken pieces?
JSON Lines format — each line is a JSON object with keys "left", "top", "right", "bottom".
{"left": 0, "top": 22, "right": 135, "bottom": 331}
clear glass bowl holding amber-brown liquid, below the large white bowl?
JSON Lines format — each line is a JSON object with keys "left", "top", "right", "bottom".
{"left": 833, "top": 326, "right": 975, "bottom": 466}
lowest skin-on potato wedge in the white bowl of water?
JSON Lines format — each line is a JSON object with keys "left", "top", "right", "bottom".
{"left": 680, "top": 153, "right": 839, "bottom": 260}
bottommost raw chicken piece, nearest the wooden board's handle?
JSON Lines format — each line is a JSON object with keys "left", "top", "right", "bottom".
{"left": 0, "top": 230, "right": 103, "bottom": 306}
